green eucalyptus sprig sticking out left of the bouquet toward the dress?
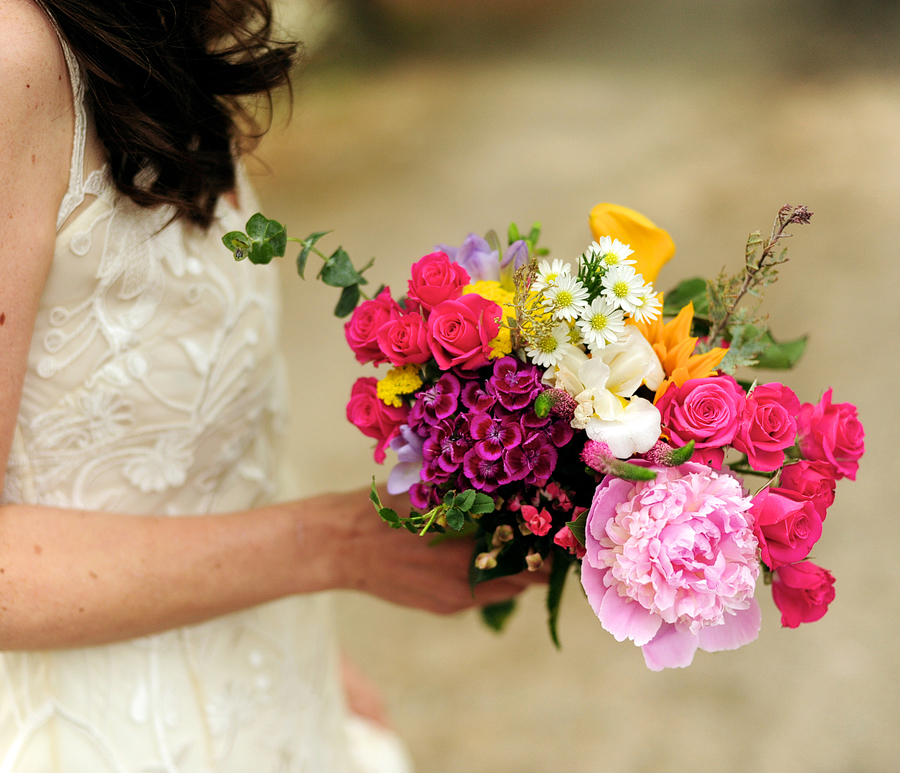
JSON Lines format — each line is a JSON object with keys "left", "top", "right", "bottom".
{"left": 222, "top": 212, "right": 375, "bottom": 317}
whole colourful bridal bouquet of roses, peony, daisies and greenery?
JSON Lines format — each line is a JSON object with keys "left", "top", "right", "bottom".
{"left": 226, "top": 204, "right": 864, "bottom": 670}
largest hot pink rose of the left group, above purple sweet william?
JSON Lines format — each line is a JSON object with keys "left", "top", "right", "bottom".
{"left": 428, "top": 293, "right": 503, "bottom": 370}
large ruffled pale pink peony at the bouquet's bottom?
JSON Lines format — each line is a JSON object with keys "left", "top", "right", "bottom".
{"left": 581, "top": 462, "right": 761, "bottom": 671}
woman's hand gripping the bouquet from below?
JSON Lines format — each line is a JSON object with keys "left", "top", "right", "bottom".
{"left": 316, "top": 489, "right": 547, "bottom": 614}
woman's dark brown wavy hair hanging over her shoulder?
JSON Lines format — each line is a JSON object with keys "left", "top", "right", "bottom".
{"left": 40, "top": 0, "right": 297, "bottom": 228}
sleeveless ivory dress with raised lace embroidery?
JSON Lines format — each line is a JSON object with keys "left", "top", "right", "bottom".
{"left": 0, "top": 25, "right": 414, "bottom": 773}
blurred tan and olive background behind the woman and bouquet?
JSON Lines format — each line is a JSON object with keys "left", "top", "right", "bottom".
{"left": 252, "top": 0, "right": 900, "bottom": 773}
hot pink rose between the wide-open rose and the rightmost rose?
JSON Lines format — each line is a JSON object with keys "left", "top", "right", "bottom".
{"left": 733, "top": 383, "right": 800, "bottom": 472}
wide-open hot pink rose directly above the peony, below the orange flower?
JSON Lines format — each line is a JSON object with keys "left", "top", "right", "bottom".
{"left": 656, "top": 376, "right": 747, "bottom": 470}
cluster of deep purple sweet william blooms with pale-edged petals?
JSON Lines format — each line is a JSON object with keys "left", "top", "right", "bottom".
{"left": 408, "top": 357, "right": 573, "bottom": 508}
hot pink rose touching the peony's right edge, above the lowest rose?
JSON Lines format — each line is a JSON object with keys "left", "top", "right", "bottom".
{"left": 752, "top": 488, "right": 822, "bottom": 569}
